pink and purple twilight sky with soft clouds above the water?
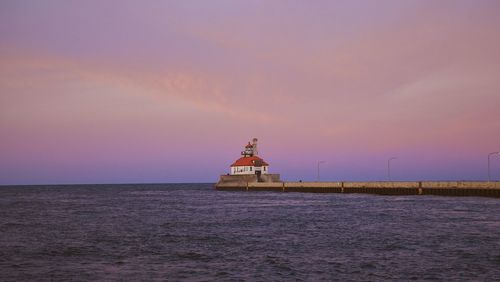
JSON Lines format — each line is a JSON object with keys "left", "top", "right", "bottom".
{"left": 0, "top": 0, "right": 500, "bottom": 185}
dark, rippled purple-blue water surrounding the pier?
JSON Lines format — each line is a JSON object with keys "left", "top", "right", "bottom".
{"left": 0, "top": 184, "right": 500, "bottom": 281}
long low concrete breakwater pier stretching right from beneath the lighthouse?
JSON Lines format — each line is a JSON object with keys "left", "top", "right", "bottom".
{"left": 215, "top": 181, "right": 500, "bottom": 197}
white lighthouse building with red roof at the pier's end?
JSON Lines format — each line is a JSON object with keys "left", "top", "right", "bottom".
{"left": 230, "top": 138, "right": 269, "bottom": 176}
